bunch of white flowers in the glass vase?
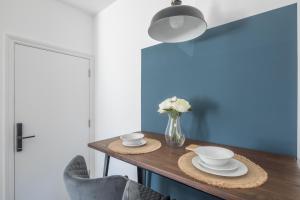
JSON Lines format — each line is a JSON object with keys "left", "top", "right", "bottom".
{"left": 158, "top": 97, "right": 191, "bottom": 113}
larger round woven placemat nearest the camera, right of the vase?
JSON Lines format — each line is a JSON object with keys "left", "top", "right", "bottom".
{"left": 178, "top": 152, "right": 268, "bottom": 189}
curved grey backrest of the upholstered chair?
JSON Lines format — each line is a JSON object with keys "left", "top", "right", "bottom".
{"left": 64, "top": 156, "right": 127, "bottom": 200}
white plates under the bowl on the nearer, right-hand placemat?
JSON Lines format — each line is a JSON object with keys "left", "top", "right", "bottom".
{"left": 192, "top": 156, "right": 248, "bottom": 177}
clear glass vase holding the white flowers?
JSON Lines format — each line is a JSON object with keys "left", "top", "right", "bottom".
{"left": 165, "top": 114, "right": 185, "bottom": 147}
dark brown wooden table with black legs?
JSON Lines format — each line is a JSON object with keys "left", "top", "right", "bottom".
{"left": 88, "top": 132, "right": 300, "bottom": 200}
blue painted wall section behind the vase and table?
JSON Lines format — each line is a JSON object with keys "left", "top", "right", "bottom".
{"left": 142, "top": 4, "right": 297, "bottom": 200}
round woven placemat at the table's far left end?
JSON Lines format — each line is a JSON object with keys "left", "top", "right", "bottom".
{"left": 108, "top": 138, "right": 161, "bottom": 154}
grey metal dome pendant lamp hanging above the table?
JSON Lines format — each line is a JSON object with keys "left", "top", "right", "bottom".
{"left": 148, "top": 0, "right": 207, "bottom": 43}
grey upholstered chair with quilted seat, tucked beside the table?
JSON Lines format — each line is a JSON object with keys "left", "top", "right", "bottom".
{"left": 64, "top": 156, "right": 169, "bottom": 200}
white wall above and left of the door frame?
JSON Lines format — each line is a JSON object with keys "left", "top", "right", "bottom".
{"left": 0, "top": 0, "right": 93, "bottom": 200}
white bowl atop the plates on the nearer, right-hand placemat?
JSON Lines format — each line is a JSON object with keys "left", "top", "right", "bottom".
{"left": 194, "top": 146, "right": 234, "bottom": 166}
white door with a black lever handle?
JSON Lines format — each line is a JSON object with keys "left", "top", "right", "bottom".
{"left": 14, "top": 44, "right": 90, "bottom": 200}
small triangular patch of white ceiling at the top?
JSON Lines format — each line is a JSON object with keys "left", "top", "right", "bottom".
{"left": 59, "top": 0, "right": 116, "bottom": 15}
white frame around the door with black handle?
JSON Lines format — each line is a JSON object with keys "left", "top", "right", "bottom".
{"left": 4, "top": 34, "right": 95, "bottom": 200}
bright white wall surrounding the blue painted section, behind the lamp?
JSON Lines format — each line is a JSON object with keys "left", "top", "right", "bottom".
{"left": 95, "top": 0, "right": 297, "bottom": 178}
